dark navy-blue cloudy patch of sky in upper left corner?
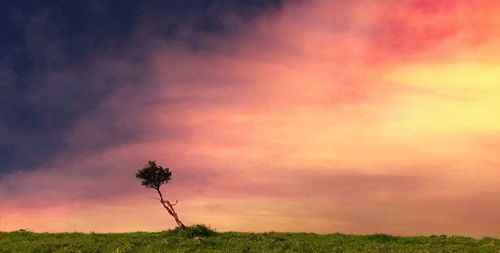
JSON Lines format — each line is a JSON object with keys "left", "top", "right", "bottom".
{"left": 0, "top": 0, "right": 282, "bottom": 176}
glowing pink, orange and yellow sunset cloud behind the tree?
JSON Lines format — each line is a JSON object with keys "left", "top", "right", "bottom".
{"left": 0, "top": 1, "right": 498, "bottom": 234}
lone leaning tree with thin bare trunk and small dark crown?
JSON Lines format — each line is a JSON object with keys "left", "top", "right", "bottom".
{"left": 135, "top": 161, "right": 186, "bottom": 229}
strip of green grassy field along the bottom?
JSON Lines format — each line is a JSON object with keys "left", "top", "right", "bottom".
{"left": 0, "top": 227, "right": 500, "bottom": 253}
